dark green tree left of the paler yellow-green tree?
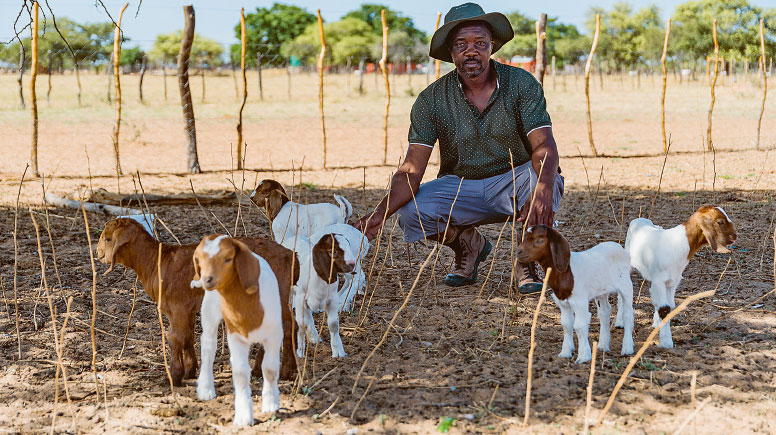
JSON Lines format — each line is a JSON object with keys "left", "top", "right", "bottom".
{"left": 229, "top": 3, "right": 317, "bottom": 67}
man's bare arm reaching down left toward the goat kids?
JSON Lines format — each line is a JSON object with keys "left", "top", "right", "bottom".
{"left": 355, "top": 144, "right": 433, "bottom": 240}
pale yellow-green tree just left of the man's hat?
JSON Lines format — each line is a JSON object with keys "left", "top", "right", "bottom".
{"left": 281, "top": 17, "right": 382, "bottom": 65}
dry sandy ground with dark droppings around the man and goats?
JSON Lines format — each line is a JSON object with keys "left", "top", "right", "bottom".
{"left": 0, "top": 72, "right": 776, "bottom": 433}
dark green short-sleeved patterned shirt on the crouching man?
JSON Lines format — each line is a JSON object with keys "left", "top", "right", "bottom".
{"left": 409, "top": 61, "right": 551, "bottom": 180}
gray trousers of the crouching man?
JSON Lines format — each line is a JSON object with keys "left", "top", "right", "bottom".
{"left": 397, "top": 161, "right": 563, "bottom": 243}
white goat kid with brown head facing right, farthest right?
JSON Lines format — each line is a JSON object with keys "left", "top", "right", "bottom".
{"left": 615, "top": 205, "right": 736, "bottom": 349}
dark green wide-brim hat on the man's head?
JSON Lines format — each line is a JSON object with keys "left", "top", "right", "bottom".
{"left": 428, "top": 3, "right": 515, "bottom": 62}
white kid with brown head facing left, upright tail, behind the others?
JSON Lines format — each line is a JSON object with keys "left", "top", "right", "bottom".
{"left": 251, "top": 180, "right": 353, "bottom": 243}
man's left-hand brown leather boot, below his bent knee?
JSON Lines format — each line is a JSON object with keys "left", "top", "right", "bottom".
{"left": 436, "top": 227, "right": 491, "bottom": 287}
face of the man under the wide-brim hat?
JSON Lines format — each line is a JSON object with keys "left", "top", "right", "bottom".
{"left": 449, "top": 23, "right": 493, "bottom": 78}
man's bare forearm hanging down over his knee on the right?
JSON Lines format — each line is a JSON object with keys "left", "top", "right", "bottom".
{"left": 518, "top": 127, "right": 558, "bottom": 227}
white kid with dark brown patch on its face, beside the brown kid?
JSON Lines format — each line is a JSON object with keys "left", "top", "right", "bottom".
{"left": 283, "top": 234, "right": 356, "bottom": 358}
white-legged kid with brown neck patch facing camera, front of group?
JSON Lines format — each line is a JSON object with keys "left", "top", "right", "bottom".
{"left": 191, "top": 235, "right": 283, "bottom": 426}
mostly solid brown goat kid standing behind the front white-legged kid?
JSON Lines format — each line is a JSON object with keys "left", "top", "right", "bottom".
{"left": 97, "top": 218, "right": 299, "bottom": 386}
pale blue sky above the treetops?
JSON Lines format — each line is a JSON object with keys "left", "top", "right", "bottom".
{"left": 0, "top": 0, "right": 776, "bottom": 50}
